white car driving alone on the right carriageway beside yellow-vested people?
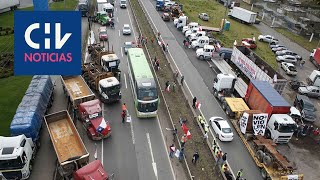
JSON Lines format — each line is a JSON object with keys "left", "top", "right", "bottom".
{"left": 209, "top": 117, "right": 233, "bottom": 141}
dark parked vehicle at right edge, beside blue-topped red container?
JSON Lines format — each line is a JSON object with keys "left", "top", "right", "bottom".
{"left": 293, "top": 94, "right": 316, "bottom": 122}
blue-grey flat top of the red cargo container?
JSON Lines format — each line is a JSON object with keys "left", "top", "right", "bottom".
{"left": 251, "top": 80, "right": 290, "bottom": 106}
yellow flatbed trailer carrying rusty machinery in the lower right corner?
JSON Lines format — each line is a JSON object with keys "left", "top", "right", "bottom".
{"left": 231, "top": 120, "right": 303, "bottom": 180}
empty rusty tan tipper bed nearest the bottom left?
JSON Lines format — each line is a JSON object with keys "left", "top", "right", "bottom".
{"left": 44, "top": 110, "right": 89, "bottom": 177}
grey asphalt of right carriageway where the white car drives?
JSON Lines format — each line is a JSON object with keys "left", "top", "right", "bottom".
{"left": 142, "top": 0, "right": 262, "bottom": 179}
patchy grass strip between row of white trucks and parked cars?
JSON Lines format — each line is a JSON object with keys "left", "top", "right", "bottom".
{"left": 178, "top": 0, "right": 278, "bottom": 69}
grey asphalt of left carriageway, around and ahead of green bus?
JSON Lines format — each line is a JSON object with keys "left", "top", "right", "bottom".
{"left": 89, "top": 3, "right": 174, "bottom": 180}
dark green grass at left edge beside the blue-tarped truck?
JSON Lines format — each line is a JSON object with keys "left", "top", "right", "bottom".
{"left": 0, "top": 76, "right": 32, "bottom": 136}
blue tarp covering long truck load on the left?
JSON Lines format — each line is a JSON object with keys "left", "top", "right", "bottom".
{"left": 10, "top": 75, "right": 54, "bottom": 141}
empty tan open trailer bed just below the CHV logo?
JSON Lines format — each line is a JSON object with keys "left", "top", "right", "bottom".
{"left": 61, "top": 76, "right": 95, "bottom": 109}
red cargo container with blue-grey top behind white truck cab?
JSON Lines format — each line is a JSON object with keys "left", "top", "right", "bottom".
{"left": 245, "top": 80, "right": 291, "bottom": 117}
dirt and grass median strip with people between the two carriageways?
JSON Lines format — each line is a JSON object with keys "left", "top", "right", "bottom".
{"left": 131, "top": 0, "right": 223, "bottom": 180}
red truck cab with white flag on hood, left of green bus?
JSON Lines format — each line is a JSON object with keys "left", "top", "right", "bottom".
{"left": 79, "top": 99, "right": 111, "bottom": 140}
